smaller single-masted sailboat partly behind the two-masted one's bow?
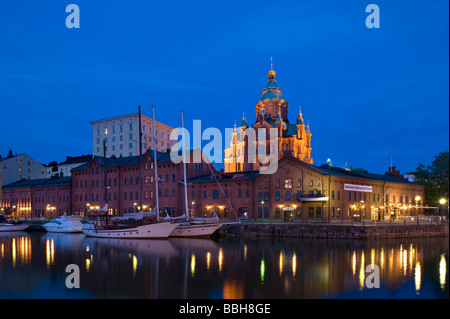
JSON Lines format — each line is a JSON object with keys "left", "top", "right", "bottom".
{"left": 170, "top": 111, "right": 222, "bottom": 237}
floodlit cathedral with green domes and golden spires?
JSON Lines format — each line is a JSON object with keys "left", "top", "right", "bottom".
{"left": 224, "top": 65, "right": 313, "bottom": 173}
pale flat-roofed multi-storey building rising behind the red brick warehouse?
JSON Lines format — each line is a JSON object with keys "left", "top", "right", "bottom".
{"left": 90, "top": 113, "right": 176, "bottom": 157}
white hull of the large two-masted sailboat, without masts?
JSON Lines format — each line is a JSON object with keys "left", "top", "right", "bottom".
{"left": 83, "top": 222, "right": 179, "bottom": 239}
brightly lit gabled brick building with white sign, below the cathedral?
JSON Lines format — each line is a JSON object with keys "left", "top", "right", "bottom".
{"left": 188, "top": 156, "right": 424, "bottom": 221}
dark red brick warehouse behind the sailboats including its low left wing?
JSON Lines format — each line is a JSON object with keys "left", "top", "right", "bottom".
{"left": 0, "top": 149, "right": 215, "bottom": 218}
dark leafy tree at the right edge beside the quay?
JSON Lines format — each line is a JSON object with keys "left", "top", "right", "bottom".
{"left": 416, "top": 152, "right": 449, "bottom": 206}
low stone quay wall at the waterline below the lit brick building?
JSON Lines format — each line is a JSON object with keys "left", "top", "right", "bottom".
{"left": 218, "top": 223, "right": 449, "bottom": 239}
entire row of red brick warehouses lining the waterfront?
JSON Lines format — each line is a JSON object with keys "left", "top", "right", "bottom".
{"left": 2, "top": 151, "right": 424, "bottom": 221}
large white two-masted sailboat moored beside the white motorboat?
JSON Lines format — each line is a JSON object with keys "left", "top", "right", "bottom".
{"left": 83, "top": 106, "right": 179, "bottom": 239}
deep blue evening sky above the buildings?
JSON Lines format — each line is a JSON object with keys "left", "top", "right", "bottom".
{"left": 0, "top": 0, "right": 449, "bottom": 173}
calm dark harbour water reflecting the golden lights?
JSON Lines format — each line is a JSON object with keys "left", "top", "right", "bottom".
{"left": 0, "top": 232, "right": 449, "bottom": 299}
